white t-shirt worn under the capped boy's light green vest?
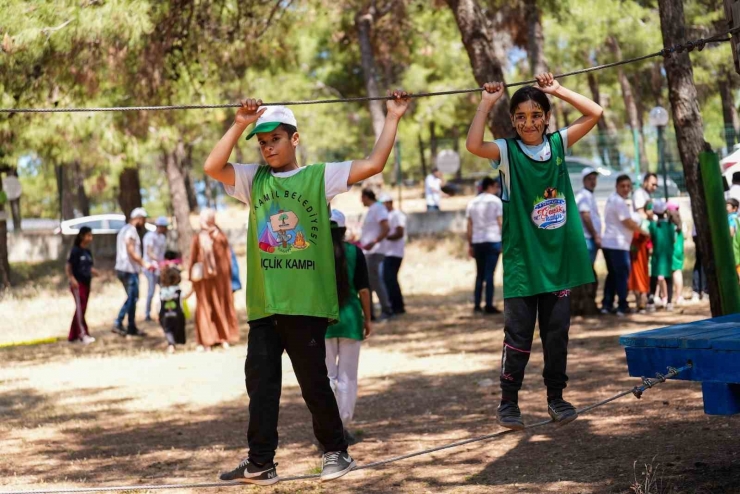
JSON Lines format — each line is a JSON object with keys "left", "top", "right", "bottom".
{"left": 224, "top": 161, "right": 352, "bottom": 204}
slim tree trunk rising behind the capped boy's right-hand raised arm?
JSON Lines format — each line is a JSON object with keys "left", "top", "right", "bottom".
{"left": 355, "top": 2, "right": 385, "bottom": 187}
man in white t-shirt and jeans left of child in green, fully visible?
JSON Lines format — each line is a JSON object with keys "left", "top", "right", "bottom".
{"left": 601, "top": 175, "right": 646, "bottom": 317}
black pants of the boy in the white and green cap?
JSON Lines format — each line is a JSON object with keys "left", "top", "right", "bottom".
{"left": 244, "top": 315, "right": 347, "bottom": 464}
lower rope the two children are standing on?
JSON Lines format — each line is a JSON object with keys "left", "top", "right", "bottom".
{"left": 0, "top": 361, "right": 693, "bottom": 494}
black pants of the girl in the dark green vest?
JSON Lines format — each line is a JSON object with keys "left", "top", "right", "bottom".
{"left": 501, "top": 290, "right": 570, "bottom": 401}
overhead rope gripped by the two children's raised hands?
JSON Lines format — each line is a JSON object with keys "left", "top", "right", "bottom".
{"left": 0, "top": 27, "right": 740, "bottom": 113}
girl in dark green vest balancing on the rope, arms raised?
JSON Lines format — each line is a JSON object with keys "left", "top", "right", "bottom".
{"left": 466, "top": 74, "right": 603, "bottom": 429}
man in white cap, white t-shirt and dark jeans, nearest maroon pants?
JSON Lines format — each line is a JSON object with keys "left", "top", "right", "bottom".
{"left": 113, "top": 208, "right": 149, "bottom": 336}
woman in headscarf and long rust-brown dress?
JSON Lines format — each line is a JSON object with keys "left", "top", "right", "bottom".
{"left": 190, "top": 209, "right": 239, "bottom": 351}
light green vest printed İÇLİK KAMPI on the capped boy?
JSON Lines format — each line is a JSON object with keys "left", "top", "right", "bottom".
{"left": 247, "top": 163, "right": 339, "bottom": 321}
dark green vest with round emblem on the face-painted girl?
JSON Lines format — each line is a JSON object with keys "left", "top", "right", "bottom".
{"left": 502, "top": 132, "right": 594, "bottom": 298}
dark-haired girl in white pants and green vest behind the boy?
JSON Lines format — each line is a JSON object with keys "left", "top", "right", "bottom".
{"left": 326, "top": 209, "right": 372, "bottom": 445}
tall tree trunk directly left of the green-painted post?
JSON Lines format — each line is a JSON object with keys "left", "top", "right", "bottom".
{"left": 658, "top": 0, "right": 726, "bottom": 316}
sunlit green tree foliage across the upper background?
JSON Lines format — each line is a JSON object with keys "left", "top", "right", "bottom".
{"left": 0, "top": 0, "right": 737, "bottom": 217}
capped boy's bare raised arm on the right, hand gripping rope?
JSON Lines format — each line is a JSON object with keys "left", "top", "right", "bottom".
{"left": 347, "top": 91, "right": 410, "bottom": 185}
